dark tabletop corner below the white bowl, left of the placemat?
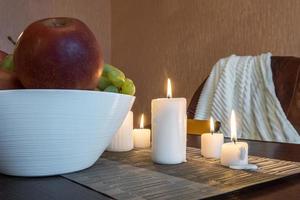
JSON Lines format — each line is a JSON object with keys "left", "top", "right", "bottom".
{"left": 0, "top": 173, "right": 113, "bottom": 200}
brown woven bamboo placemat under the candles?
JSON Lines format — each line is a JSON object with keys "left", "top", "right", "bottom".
{"left": 64, "top": 147, "right": 300, "bottom": 200}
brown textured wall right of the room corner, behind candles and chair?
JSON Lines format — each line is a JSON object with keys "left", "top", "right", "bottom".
{"left": 112, "top": 0, "right": 300, "bottom": 123}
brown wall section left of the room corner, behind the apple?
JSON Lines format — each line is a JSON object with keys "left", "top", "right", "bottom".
{"left": 0, "top": 0, "right": 111, "bottom": 62}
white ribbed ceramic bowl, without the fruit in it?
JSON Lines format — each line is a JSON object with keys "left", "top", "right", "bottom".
{"left": 0, "top": 90, "right": 135, "bottom": 176}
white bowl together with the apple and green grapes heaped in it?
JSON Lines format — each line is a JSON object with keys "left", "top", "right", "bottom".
{"left": 0, "top": 18, "right": 135, "bottom": 176}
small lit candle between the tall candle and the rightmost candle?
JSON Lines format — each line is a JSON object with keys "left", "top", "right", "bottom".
{"left": 201, "top": 117, "right": 224, "bottom": 159}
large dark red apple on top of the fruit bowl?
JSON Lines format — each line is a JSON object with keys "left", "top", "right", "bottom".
{"left": 14, "top": 17, "right": 103, "bottom": 90}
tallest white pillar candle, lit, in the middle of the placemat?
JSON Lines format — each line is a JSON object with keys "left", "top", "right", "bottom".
{"left": 151, "top": 79, "right": 187, "bottom": 164}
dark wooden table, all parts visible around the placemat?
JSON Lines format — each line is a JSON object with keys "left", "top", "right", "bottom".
{"left": 0, "top": 136, "right": 300, "bottom": 200}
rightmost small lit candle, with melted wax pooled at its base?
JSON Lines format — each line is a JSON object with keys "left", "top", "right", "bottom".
{"left": 221, "top": 110, "right": 248, "bottom": 166}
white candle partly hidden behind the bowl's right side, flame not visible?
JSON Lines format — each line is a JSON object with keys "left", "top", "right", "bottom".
{"left": 106, "top": 111, "right": 133, "bottom": 152}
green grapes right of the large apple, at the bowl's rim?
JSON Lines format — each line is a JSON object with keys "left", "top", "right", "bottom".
{"left": 98, "top": 64, "right": 135, "bottom": 95}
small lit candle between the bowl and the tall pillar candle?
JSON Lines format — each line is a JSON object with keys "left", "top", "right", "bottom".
{"left": 133, "top": 114, "right": 151, "bottom": 148}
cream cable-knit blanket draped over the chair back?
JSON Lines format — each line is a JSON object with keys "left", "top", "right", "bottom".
{"left": 195, "top": 53, "right": 300, "bottom": 144}
